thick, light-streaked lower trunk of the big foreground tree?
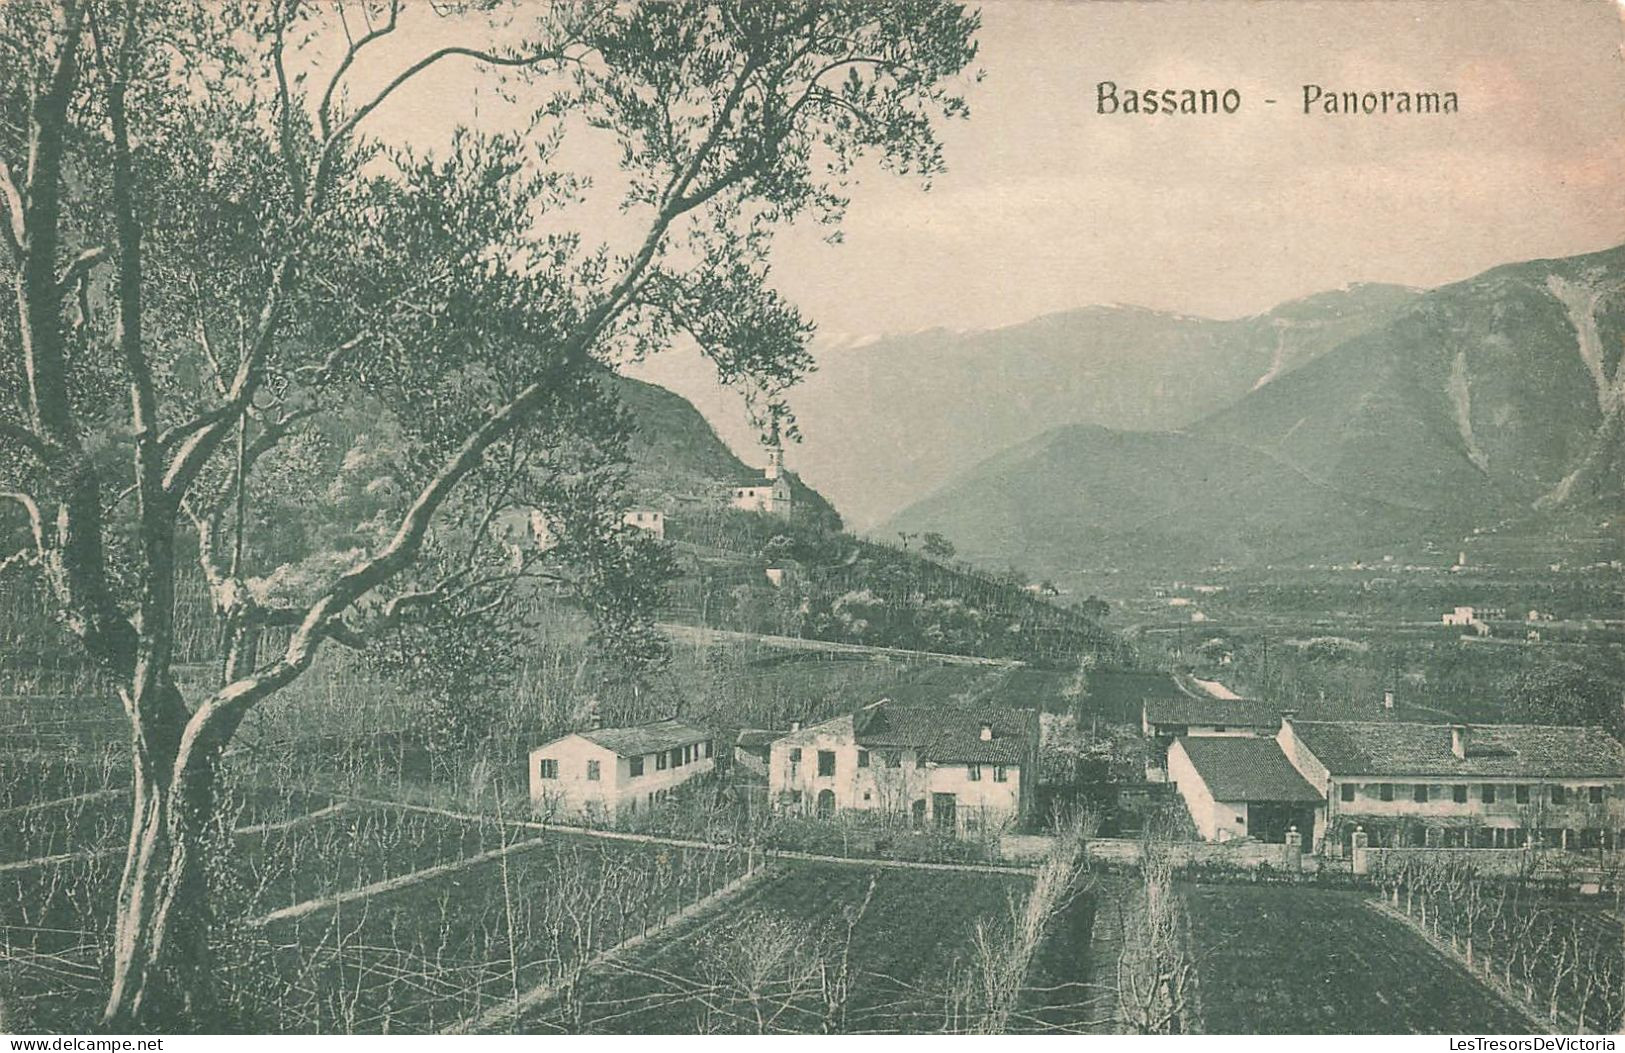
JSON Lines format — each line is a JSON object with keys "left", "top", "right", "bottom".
{"left": 102, "top": 698, "right": 223, "bottom": 1032}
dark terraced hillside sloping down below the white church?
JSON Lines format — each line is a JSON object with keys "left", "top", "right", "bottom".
{"left": 611, "top": 377, "right": 1107, "bottom": 661}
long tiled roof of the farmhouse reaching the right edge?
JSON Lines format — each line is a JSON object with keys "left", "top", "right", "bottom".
{"left": 1292, "top": 720, "right": 1625, "bottom": 778}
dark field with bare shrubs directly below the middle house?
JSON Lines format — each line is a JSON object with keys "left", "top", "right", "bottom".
{"left": 523, "top": 863, "right": 1029, "bottom": 1034}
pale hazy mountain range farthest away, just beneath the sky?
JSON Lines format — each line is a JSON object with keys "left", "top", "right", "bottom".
{"left": 647, "top": 284, "right": 1415, "bottom": 528}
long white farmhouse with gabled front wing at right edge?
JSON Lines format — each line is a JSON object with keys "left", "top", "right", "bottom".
{"left": 1168, "top": 712, "right": 1625, "bottom": 853}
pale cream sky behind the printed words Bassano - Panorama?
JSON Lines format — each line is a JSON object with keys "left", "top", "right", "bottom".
{"left": 352, "top": 0, "right": 1625, "bottom": 457}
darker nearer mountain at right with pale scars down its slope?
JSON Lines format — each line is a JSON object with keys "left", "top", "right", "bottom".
{"left": 889, "top": 247, "right": 1625, "bottom": 577}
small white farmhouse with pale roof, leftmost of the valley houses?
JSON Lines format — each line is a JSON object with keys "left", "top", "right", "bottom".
{"left": 530, "top": 718, "right": 717, "bottom": 821}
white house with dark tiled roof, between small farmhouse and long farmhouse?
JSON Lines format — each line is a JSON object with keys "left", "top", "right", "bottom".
{"left": 769, "top": 699, "right": 1038, "bottom": 834}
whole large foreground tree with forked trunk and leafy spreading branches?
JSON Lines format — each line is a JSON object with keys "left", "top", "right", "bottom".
{"left": 0, "top": 0, "right": 977, "bottom": 1029}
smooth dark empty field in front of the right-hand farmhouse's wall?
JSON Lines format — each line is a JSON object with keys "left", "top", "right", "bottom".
{"left": 1185, "top": 884, "right": 1529, "bottom": 1035}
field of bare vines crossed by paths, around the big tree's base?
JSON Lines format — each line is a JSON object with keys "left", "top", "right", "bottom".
{"left": 0, "top": 776, "right": 744, "bottom": 1032}
